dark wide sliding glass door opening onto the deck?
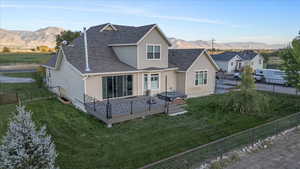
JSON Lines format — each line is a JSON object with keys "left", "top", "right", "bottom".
{"left": 102, "top": 75, "right": 133, "bottom": 99}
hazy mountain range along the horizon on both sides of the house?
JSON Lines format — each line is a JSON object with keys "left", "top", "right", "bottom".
{"left": 0, "top": 27, "right": 285, "bottom": 49}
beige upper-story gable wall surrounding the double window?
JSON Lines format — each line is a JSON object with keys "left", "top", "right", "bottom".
{"left": 137, "top": 28, "right": 168, "bottom": 69}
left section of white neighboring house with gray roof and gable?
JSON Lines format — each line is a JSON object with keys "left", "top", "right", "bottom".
{"left": 212, "top": 52, "right": 242, "bottom": 73}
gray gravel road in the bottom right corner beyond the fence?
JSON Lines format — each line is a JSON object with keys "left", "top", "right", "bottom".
{"left": 226, "top": 129, "right": 300, "bottom": 169}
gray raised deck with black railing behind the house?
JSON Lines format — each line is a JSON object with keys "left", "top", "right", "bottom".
{"left": 85, "top": 96, "right": 169, "bottom": 126}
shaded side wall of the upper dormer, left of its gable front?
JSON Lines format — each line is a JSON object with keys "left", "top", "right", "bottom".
{"left": 112, "top": 46, "right": 137, "bottom": 68}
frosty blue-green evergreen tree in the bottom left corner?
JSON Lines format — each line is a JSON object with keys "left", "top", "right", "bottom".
{"left": 0, "top": 106, "right": 57, "bottom": 169}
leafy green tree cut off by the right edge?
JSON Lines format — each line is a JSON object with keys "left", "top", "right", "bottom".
{"left": 280, "top": 32, "right": 300, "bottom": 91}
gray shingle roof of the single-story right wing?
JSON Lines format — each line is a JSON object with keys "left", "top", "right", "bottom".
{"left": 169, "top": 49, "right": 204, "bottom": 71}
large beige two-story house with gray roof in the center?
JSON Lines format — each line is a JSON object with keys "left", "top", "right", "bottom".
{"left": 44, "top": 23, "right": 218, "bottom": 109}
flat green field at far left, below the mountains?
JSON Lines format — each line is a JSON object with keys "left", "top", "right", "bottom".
{"left": 0, "top": 53, "right": 53, "bottom": 65}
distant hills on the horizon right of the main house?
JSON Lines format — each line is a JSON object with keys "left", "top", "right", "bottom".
{"left": 169, "top": 38, "right": 286, "bottom": 49}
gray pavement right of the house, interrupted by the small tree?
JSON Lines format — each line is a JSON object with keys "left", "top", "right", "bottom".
{"left": 217, "top": 79, "right": 300, "bottom": 95}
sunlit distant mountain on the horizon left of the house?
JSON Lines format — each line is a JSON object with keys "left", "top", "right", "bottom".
{"left": 0, "top": 27, "right": 64, "bottom": 49}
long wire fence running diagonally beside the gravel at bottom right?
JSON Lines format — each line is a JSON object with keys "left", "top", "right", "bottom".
{"left": 140, "top": 113, "right": 300, "bottom": 169}
